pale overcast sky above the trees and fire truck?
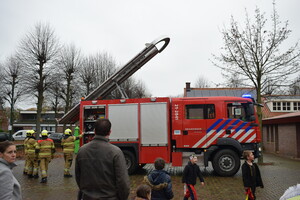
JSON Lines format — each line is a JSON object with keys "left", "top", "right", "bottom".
{"left": 0, "top": 0, "right": 300, "bottom": 101}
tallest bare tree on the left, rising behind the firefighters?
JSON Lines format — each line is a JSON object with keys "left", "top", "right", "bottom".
{"left": 18, "top": 23, "right": 60, "bottom": 132}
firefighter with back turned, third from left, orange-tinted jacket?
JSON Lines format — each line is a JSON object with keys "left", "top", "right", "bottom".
{"left": 35, "top": 130, "right": 55, "bottom": 183}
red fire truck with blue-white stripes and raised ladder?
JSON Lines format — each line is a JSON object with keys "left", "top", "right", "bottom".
{"left": 60, "top": 37, "right": 260, "bottom": 176}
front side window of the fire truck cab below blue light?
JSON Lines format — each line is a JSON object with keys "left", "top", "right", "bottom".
{"left": 227, "top": 102, "right": 255, "bottom": 121}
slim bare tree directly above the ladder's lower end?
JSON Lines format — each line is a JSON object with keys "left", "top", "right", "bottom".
{"left": 59, "top": 44, "right": 82, "bottom": 113}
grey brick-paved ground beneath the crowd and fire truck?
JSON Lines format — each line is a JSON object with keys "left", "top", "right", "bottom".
{"left": 14, "top": 154, "right": 300, "bottom": 200}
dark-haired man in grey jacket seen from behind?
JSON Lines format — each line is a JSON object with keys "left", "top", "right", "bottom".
{"left": 75, "top": 119, "right": 130, "bottom": 200}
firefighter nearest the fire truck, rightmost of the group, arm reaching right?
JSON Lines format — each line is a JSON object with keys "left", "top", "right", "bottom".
{"left": 61, "top": 128, "right": 82, "bottom": 177}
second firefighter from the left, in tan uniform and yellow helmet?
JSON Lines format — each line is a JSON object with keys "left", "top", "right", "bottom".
{"left": 26, "top": 130, "right": 39, "bottom": 178}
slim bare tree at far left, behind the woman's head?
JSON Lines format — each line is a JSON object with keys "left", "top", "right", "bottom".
{"left": 2, "top": 56, "right": 24, "bottom": 136}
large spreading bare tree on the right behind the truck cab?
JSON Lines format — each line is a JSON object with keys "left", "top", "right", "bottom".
{"left": 213, "top": 4, "right": 300, "bottom": 162}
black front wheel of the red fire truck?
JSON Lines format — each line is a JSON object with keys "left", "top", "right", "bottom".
{"left": 212, "top": 149, "right": 241, "bottom": 176}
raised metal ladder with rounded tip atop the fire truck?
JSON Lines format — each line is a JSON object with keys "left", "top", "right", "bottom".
{"left": 59, "top": 37, "right": 170, "bottom": 124}
